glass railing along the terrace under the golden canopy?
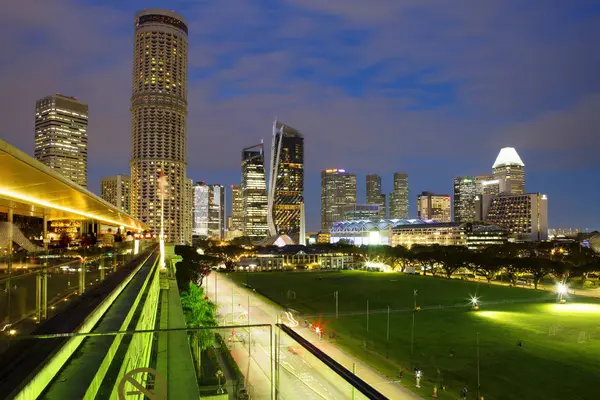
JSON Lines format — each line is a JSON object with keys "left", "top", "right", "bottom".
{"left": 0, "top": 240, "right": 154, "bottom": 336}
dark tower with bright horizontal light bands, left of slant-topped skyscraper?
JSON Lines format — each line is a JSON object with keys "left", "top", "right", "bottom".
{"left": 241, "top": 143, "right": 269, "bottom": 240}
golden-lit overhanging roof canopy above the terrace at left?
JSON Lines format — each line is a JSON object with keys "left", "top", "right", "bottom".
{"left": 0, "top": 140, "right": 148, "bottom": 230}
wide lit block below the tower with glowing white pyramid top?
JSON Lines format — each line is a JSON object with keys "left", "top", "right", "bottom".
{"left": 475, "top": 193, "right": 548, "bottom": 241}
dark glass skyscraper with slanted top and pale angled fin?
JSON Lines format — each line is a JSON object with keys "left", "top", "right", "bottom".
{"left": 267, "top": 120, "right": 304, "bottom": 243}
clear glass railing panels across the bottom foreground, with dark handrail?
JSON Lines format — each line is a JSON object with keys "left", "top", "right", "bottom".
{"left": 0, "top": 324, "right": 376, "bottom": 400}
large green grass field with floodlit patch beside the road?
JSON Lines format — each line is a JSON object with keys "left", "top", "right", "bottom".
{"left": 232, "top": 271, "right": 600, "bottom": 400}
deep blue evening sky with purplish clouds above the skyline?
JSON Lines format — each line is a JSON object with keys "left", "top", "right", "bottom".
{"left": 0, "top": 0, "right": 600, "bottom": 231}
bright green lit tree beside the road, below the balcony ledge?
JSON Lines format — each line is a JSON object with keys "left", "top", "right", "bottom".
{"left": 181, "top": 283, "right": 217, "bottom": 374}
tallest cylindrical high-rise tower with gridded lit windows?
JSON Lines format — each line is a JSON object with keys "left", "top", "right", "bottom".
{"left": 131, "top": 9, "right": 188, "bottom": 243}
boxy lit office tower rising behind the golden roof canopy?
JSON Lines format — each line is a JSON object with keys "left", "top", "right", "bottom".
{"left": 35, "top": 94, "right": 88, "bottom": 187}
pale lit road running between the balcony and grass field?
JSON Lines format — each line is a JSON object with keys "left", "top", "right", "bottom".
{"left": 204, "top": 273, "right": 420, "bottom": 400}
